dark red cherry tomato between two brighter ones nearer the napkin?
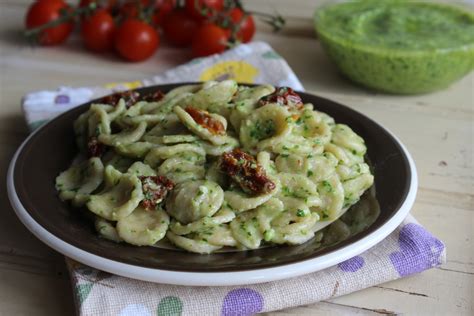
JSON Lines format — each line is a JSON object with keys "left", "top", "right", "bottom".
{"left": 163, "top": 10, "right": 198, "bottom": 47}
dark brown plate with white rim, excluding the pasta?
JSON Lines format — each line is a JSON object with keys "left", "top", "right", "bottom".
{"left": 8, "top": 84, "right": 417, "bottom": 285}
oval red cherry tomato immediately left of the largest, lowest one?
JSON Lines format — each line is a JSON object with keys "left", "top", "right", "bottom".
{"left": 81, "top": 9, "right": 115, "bottom": 52}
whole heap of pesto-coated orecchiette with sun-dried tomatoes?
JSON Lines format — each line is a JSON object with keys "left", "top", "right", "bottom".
{"left": 56, "top": 80, "right": 374, "bottom": 253}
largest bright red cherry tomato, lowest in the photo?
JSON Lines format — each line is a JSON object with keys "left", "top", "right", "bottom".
{"left": 114, "top": 19, "right": 160, "bottom": 61}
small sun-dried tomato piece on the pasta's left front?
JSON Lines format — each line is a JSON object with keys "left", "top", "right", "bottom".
{"left": 139, "top": 176, "right": 175, "bottom": 211}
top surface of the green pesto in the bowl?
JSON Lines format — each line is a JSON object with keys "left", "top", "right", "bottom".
{"left": 317, "top": 1, "right": 474, "bottom": 54}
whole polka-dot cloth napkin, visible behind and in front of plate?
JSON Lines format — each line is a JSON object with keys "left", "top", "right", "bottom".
{"left": 22, "top": 42, "right": 446, "bottom": 316}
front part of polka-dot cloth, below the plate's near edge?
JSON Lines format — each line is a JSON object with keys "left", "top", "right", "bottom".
{"left": 66, "top": 215, "right": 446, "bottom": 316}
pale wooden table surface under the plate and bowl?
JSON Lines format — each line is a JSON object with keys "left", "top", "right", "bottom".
{"left": 0, "top": 0, "right": 474, "bottom": 315}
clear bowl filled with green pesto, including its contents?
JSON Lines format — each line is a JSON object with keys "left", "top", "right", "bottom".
{"left": 315, "top": 0, "right": 474, "bottom": 94}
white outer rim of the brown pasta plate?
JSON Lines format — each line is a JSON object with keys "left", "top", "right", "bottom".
{"left": 7, "top": 83, "right": 418, "bottom": 286}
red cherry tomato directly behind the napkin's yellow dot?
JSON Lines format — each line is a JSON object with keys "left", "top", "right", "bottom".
{"left": 192, "top": 24, "right": 229, "bottom": 57}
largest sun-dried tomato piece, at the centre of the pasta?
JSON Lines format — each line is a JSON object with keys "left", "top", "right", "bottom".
{"left": 219, "top": 148, "right": 275, "bottom": 194}
